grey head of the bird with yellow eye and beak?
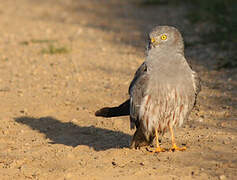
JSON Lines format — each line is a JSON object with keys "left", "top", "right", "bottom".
{"left": 147, "top": 26, "right": 184, "bottom": 53}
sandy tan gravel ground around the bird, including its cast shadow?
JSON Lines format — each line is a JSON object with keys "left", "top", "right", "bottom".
{"left": 0, "top": 0, "right": 237, "bottom": 180}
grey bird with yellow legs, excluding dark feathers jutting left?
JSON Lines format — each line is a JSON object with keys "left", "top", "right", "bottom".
{"left": 129, "top": 26, "right": 201, "bottom": 152}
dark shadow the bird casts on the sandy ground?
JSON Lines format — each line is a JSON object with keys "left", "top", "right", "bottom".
{"left": 15, "top": 116, "right": 131, "bottom": 151}
